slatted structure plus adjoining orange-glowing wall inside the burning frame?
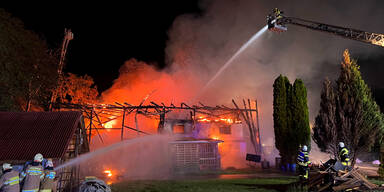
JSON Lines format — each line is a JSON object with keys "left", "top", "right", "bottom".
{"left": 163, "top": 114, "right": 252, "bottom": 173}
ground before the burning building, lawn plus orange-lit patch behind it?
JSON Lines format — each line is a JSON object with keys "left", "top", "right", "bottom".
{"left": 107, "top": 166, "right": 384, "bottom": 192}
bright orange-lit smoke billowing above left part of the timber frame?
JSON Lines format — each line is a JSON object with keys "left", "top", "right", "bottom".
{"left": 102, "top": 59, "right": 201, "bottom": 105}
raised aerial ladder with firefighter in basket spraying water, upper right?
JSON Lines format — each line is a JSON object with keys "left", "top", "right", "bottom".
{"left": 267, "top": 8, "right": 384, "bottom": 47}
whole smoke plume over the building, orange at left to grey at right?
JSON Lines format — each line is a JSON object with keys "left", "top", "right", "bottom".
{"left": 97, "top": 0, "right": 384, "bottom": 170}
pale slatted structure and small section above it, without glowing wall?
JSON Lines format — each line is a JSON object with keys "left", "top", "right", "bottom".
{"left": 162, "top": 112, "right": 223, "bottom": 173}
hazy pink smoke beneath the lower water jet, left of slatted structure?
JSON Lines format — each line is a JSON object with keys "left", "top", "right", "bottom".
{"left": 76, "top": 135, "right": 175, "bottom": 183}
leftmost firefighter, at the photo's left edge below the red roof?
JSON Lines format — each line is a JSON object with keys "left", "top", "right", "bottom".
{"left": 0, "top": 163, "right": 20, "bottom": 192}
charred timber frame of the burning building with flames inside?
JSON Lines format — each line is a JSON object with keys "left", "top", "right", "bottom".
{"left": 54, "top": 99, "right": 262, "bottom": 172}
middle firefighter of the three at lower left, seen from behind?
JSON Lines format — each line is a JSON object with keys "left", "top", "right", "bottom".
{"left": 20, "top": 153, "right": 44, "bottom": 192}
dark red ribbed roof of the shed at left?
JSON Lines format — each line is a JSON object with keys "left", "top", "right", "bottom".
{"left": 0, "top": 111, "right": 82, "bottom": 161}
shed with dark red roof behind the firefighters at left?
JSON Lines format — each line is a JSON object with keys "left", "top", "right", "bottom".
{"left": 0, "top": 111, "right": 89, "bottom": 191}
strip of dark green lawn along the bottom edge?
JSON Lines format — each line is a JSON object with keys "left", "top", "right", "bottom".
{"left": 111, "top": 176, "right": 297, "bottom": 192}
